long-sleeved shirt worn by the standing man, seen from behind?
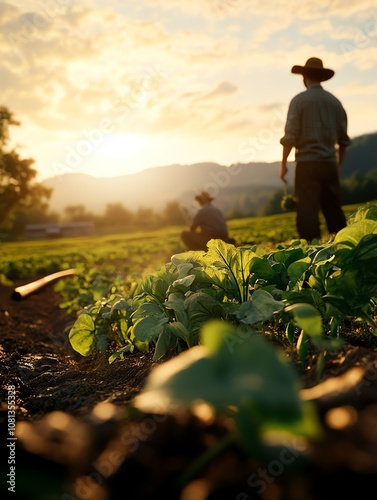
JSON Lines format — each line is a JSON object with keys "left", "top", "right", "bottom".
{"left": 280, "top": 83, "right": 351, "bottom": 161}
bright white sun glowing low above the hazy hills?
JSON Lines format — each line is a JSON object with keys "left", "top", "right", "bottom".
{"left": 99, "top": 134, "right": 147, "bottom": 160}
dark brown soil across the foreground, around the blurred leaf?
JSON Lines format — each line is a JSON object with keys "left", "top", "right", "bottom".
{"left": 0, "top": 283, "right": 377, "bottom": 500}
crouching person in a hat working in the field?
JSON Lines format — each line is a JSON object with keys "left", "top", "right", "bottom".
{"left": 181, "top": 191, "right": 235, "bottom": 250}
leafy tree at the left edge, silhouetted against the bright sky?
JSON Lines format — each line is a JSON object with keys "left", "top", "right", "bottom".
{"left": 0, "top": 106, "right": 52, "bottom": 223}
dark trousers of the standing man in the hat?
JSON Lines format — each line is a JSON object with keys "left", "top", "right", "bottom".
{"left": 295, "top": 161, "right": 347, "bottom": 241}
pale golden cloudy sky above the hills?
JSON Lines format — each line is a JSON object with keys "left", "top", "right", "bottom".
{"left": 0, "top": 0, "right": 377, "bottom": 180}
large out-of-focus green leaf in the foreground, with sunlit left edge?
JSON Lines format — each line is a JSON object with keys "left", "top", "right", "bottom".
{"left": 135, "top": 321, "right": 318, "bottom": 440}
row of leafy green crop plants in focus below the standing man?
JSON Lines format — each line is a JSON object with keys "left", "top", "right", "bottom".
{"left": 70, "top": 203, "right": 377, "bottom": 366}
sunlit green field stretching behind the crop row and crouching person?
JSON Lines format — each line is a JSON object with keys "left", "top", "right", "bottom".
{"left": 0, "top": 201, "right": 366, "bottom": 284}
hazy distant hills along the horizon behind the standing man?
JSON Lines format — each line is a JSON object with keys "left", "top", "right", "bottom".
{"left": 43, "top": 133, "right": 377, "bottom": 214}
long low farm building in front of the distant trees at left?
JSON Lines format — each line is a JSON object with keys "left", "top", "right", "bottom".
{"left": 25, "top": 221, "right": 94, "bottom": 240}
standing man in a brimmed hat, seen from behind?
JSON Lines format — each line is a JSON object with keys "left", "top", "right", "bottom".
{"left": 280, "top": 57, "right": 351, "bottom": 241}
